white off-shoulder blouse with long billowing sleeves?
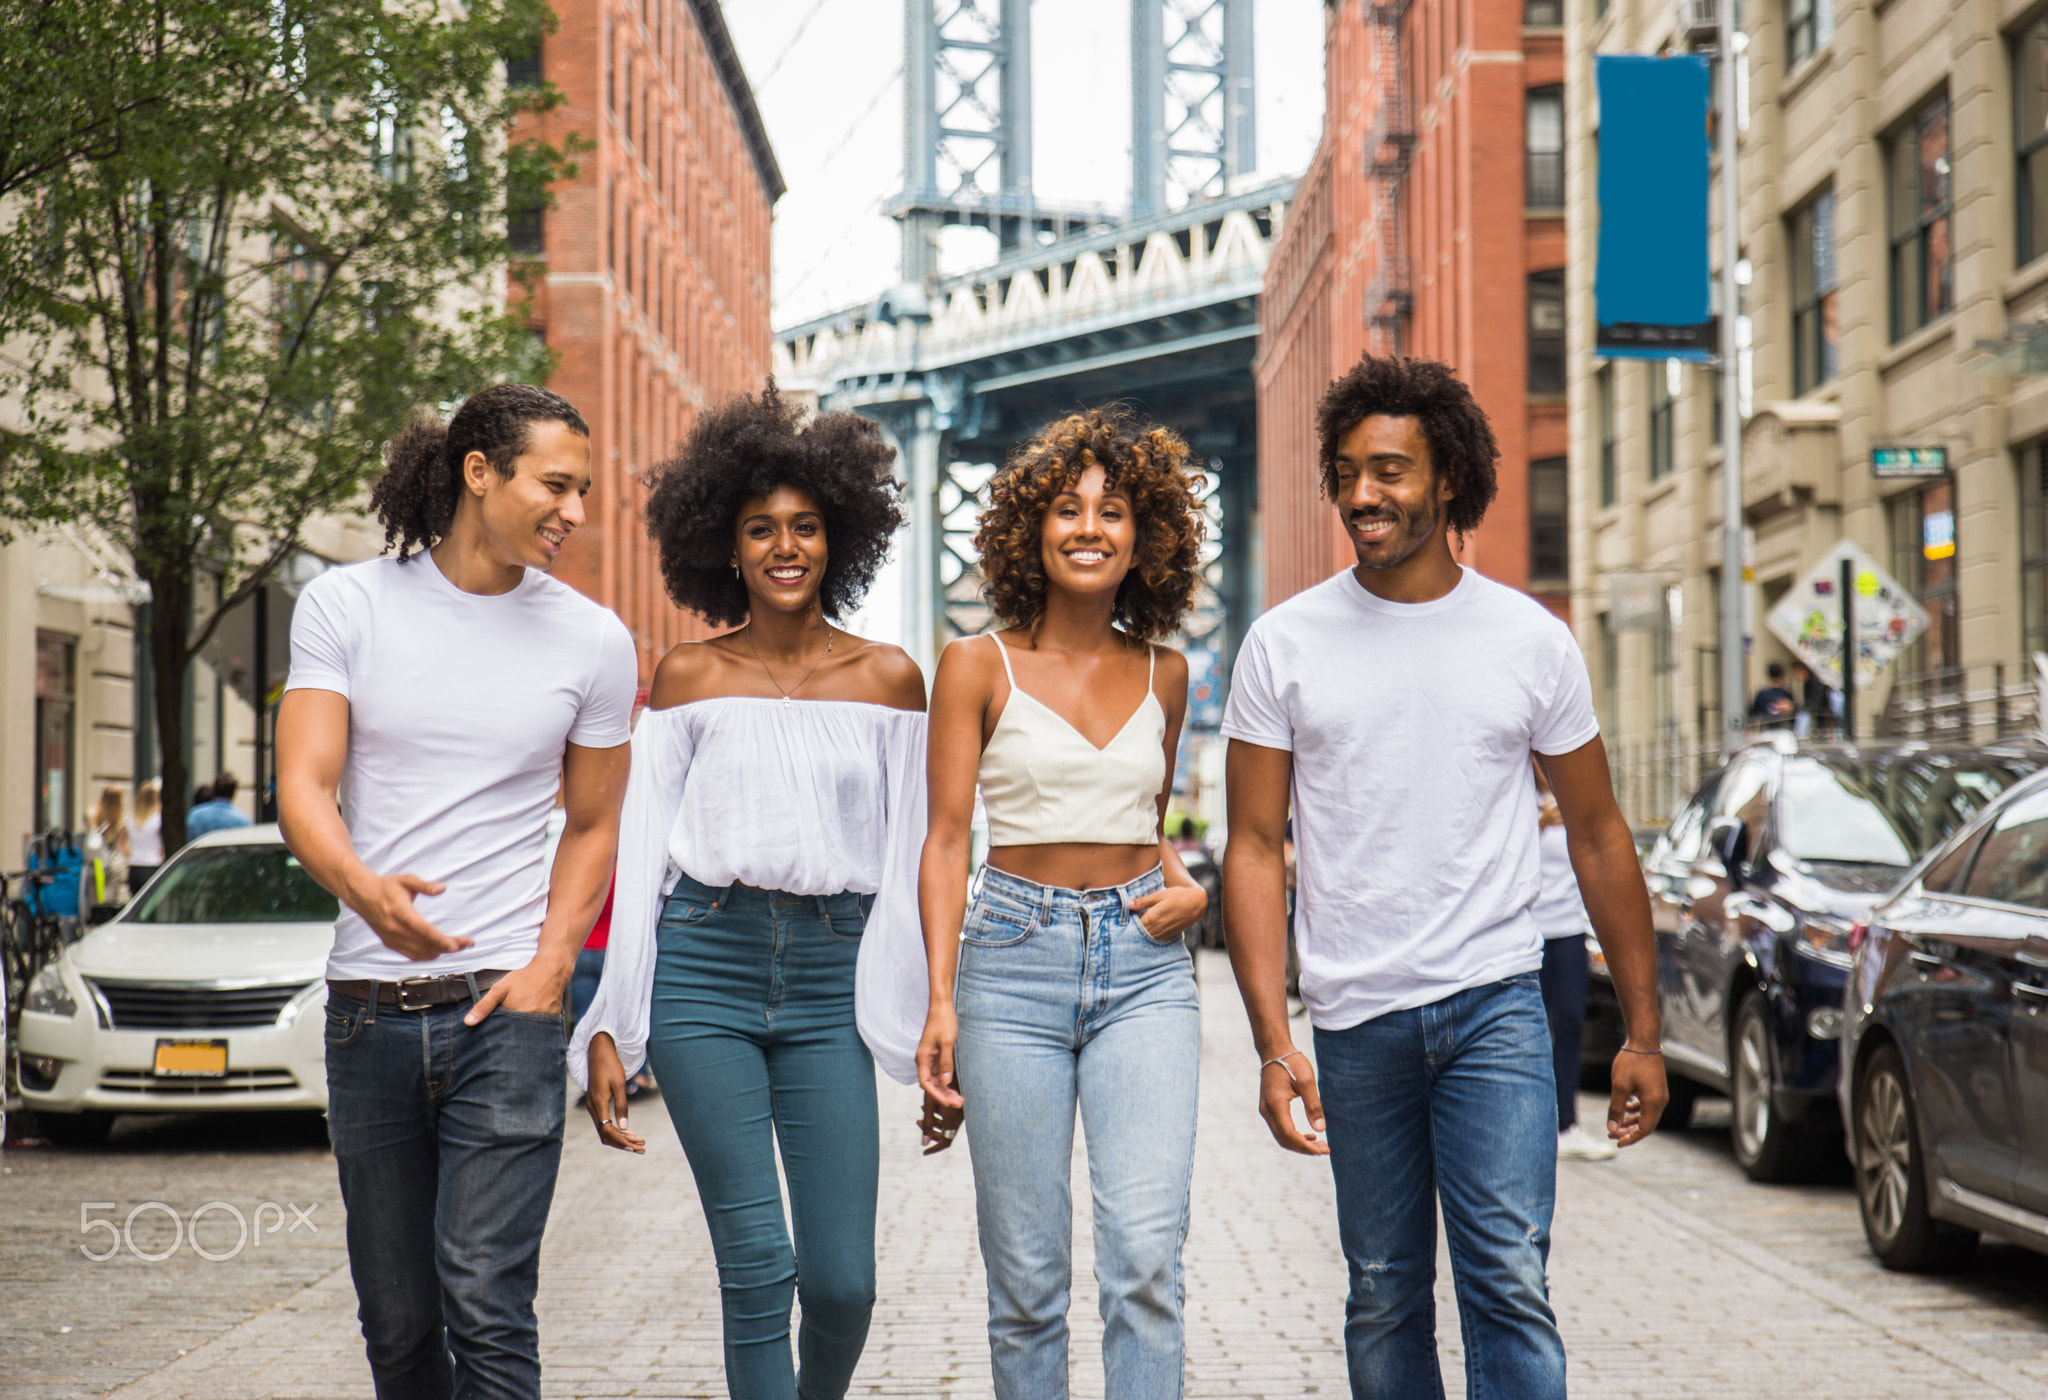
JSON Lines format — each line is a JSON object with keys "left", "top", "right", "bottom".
{"left": 569, "top": 696, "right": 928, "bottom": 1089}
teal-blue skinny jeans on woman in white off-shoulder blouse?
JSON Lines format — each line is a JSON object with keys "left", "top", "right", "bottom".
{"left": 647, "top": 876, "right": 881, "bottom": 1400}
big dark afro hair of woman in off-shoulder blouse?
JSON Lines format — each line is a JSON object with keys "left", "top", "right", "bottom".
{"left": 645, "top": 379, "right": 903, "bottom": 626}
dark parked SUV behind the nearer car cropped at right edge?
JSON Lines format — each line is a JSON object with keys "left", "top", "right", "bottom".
{"left": 1645, "top": 735, "right": 2040, "bottom": 1181}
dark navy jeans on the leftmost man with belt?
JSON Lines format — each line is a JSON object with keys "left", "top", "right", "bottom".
{"left": 326, "top": 993, "right": 567, "bottom": 1400}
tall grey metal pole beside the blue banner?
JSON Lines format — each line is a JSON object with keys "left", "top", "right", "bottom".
{"left": 1714, "top": 0, "right": 1749, "bottom": 751}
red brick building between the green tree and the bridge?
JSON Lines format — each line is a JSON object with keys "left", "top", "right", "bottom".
{"left": 508, "top": 0, "right": 782, "bottom": 680}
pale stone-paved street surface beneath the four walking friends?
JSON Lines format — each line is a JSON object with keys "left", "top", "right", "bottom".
{"left": 103, "top": 956, "right": 2048, "bottom": 1400}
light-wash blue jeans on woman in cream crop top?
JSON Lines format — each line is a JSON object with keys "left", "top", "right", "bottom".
{"left": 954, "top": 870, "right": 1202, "bottom": 1400}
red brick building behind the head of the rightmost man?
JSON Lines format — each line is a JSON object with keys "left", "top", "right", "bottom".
{"left": 1253, "top": 0, "right": 1569, "bottom": 614}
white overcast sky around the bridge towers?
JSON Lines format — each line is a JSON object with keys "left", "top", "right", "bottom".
{"left": 725, "top": 0, "right": 1323, "bottom": 325}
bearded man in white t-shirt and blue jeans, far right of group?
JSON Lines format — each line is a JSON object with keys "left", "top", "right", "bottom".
{"left": 1223, "top": 356, "right": 1667, "bottom": 1400}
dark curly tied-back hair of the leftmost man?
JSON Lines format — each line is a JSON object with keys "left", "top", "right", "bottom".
{"left": 371, "top": 385, "right": 590, "bottom": 563}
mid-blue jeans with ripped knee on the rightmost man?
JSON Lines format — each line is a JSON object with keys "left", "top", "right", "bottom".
{"left": 1315, "top": 972, "right": 1565, "bottom": 1400}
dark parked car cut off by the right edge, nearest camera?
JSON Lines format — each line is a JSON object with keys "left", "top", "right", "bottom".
{"left": 1841, "top": 774, "right": 2048, "bottom": 1269}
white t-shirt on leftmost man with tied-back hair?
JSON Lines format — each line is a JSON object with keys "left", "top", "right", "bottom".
{"left": 287, "top": 553, "right": 639, "bottom": 982}
